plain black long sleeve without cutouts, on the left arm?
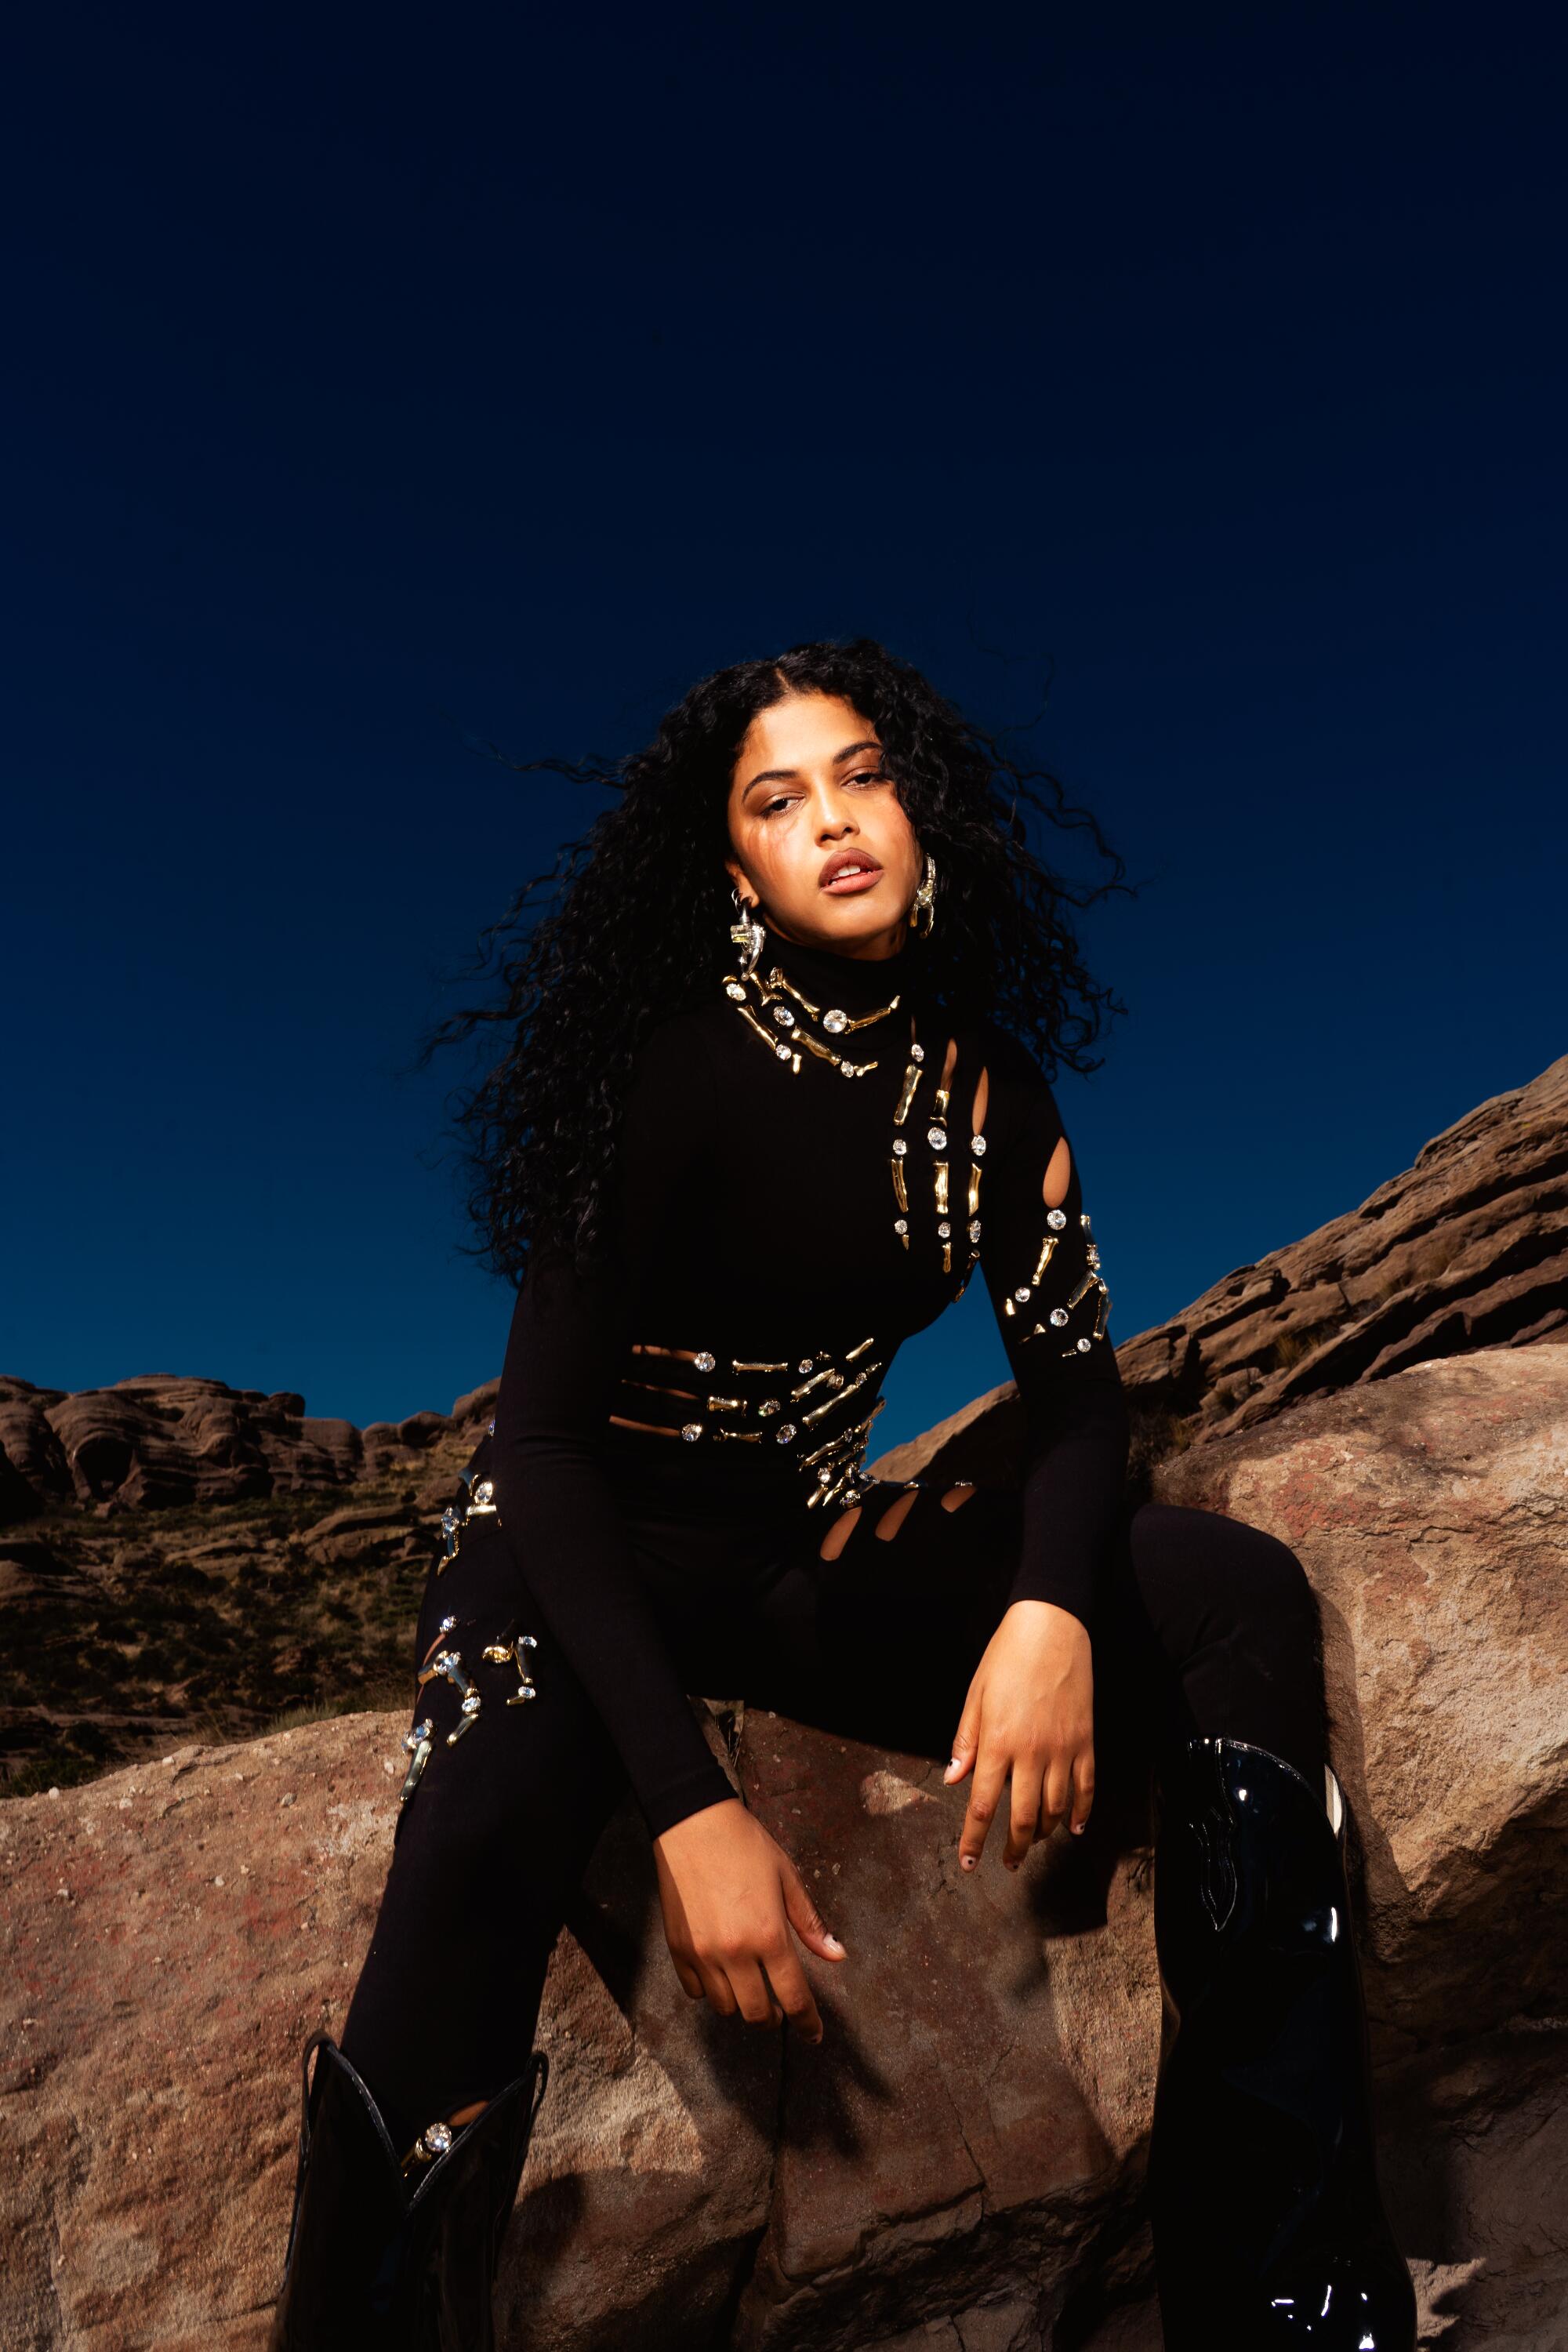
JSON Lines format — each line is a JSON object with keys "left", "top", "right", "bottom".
{"left": 494, "top": 1030, "right": 734, "bottom": 1837}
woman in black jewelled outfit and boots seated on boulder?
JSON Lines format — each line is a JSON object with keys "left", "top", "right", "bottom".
{"left": 273, "top": 642, "right": 1415, "bottom": 2352}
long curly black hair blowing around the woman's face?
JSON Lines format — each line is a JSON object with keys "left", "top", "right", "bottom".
{"left": 421, "top": 637, "right": 1128, "bottom": 1279}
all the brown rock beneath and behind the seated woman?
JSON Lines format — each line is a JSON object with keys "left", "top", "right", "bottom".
{"left": 0, "top": 1063, "right": 1568, "bottom": 2352}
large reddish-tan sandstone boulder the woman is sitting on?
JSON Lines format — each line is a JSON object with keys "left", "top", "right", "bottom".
{"left": 0, "top": 1345, "right": 1568, "bottom": 2352}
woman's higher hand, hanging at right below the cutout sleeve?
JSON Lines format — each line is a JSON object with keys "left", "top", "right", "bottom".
{"left": 942, "top": 1602, "right": 1095, "bottom": 1870}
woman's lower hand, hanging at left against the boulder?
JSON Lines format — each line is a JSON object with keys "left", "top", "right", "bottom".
{"left": 654, "top": 1797, "right": 844, "bottom": 2042}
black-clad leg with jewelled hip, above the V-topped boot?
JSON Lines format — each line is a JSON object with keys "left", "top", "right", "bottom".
{"left": 343, "top": 1524, "right": 626, "bottom": 2152}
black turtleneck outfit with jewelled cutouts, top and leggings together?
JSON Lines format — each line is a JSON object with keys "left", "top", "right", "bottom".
{"left": 293, "top": 931, "right": 1410, "bottom": 2352}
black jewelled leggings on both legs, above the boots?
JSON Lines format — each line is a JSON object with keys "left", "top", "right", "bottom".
{"left": 343, "top": 1482, "right": 1323, "bottom": 2147}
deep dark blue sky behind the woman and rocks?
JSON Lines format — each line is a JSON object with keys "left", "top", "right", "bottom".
{"left": 0, "top": 0, "right": 1568, "bottom": 1442}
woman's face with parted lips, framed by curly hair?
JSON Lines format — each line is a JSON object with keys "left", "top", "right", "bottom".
{"left": 724, "top": 694, "right": 924, "bottom": 960}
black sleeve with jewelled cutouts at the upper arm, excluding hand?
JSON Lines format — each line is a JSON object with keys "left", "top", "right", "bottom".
{"left": 980, "top": 1033, "right": 1128, "bottom": 1625}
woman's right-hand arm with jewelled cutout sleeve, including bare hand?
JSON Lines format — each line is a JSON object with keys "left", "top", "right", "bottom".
{"left": 947, "top": 1037, "right": 1126, "bottom": 1870}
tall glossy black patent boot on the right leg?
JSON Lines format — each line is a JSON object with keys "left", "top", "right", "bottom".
{"left": 1149, "top": 1740, "right": 1415, "bottom": 2352}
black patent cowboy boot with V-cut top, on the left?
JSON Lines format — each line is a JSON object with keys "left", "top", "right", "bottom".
{"left": 268, "top": 2034, "right": 548, "bottom": 2352}
